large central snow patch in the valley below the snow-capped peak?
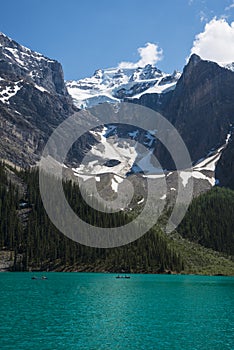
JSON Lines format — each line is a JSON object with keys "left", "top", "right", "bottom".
{"left": 73, "top": 125, "right": 162, "bottom": 178}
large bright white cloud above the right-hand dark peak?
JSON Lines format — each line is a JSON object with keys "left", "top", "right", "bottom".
{"left": 191, "top": 18, "right": 234, "bottom": 64}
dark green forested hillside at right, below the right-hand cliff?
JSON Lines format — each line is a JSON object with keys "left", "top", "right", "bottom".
{"left": 178, "top": 187, "right": 234, "bottom": 255}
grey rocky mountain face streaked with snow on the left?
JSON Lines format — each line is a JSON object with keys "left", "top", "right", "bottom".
{"left": 0, "top": 33, "right": 76, "bottom": 166}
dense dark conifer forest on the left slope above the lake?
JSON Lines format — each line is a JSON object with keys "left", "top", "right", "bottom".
{"left": 0, "top": 164, "right": 183, "bottom": 273}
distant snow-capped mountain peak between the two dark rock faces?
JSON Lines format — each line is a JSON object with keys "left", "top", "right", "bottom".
{"left": 66, "top": 64, "right": 181, "bottom": 108}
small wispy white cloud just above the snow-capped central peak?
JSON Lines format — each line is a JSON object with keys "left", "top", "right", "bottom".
{"left": 119, "top": 43, "right": 163, "bottom": 68}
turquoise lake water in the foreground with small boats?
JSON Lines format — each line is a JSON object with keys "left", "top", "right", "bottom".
{"left": 0, "top": 273, "right": 234, "bottom": 350}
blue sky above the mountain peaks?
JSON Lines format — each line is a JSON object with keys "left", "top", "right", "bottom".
{"left": 0, "top": 0, "right": 234, "bottom": 79}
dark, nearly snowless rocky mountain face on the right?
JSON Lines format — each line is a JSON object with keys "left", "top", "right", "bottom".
{"left": 130, "top": 55, "right": 234, "bottom": 169}
